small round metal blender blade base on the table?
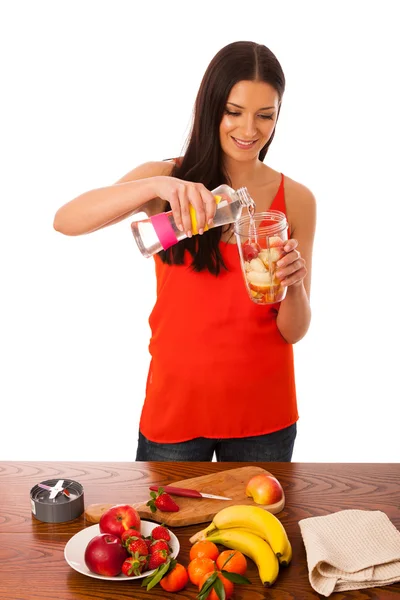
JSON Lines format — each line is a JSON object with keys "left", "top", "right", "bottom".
{"left": 30, "top": 479, "right": 85, "bottom": 523}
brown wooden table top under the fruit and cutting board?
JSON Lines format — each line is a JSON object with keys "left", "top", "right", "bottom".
{"left": 0, "top": 462, "right": 400, "bottom": 600}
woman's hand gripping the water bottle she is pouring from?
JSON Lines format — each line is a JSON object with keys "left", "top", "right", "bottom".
{"left": 154, "top": 176, "right": 217, "bottom": 237}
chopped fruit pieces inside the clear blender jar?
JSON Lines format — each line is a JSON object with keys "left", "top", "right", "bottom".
{"left": 243, "top": 236, "right": 286, "bottom": 304}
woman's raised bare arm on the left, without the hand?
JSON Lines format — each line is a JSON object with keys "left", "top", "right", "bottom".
{"left": 53, "top": 162, "right": 173, "bottom": 235}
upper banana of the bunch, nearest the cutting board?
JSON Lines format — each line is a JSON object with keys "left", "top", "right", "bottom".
{"left": 191, "top": 504, "right": 289, "bottom": 558}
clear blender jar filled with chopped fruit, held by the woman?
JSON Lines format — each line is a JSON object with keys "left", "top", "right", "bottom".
{"left": 234, "top": 210, "right": 288, "bottom": 304}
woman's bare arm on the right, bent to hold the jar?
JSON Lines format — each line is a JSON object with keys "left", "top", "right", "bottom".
{"left": 277, "top": 184, "right": 316, "bottom": 344}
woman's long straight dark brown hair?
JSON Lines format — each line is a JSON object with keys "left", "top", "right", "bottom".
{"left": 159, "top": 42, "right": 285, "bottom": 275}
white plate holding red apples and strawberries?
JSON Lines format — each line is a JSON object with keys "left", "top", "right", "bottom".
{"left": 64, "top": 521, "right": 180, "bottom": 581}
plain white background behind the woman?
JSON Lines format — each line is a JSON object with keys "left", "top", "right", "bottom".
{"left": 0, "top": 0, "right": 400, "bottom": 462}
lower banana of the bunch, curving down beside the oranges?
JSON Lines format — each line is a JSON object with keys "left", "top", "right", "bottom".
{"left": 203, "top": 528, "right": 279, "bottom": 586}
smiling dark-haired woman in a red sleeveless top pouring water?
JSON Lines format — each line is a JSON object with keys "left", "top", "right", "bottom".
{"left": 54, "top": 42, "right": 316, "bottom": 461}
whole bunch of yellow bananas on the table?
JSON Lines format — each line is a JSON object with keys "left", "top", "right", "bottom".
{"left": 190, "top": 505, "right": 292, "bottom": 586}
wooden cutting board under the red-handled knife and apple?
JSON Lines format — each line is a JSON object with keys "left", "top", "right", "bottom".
{"left": 85, "top": 467, "right": 285, "bottom": 527}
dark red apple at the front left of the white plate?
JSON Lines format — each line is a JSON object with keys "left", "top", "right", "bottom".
{"left": 85, "top": 533, "right": 129, "bottom": 577}
